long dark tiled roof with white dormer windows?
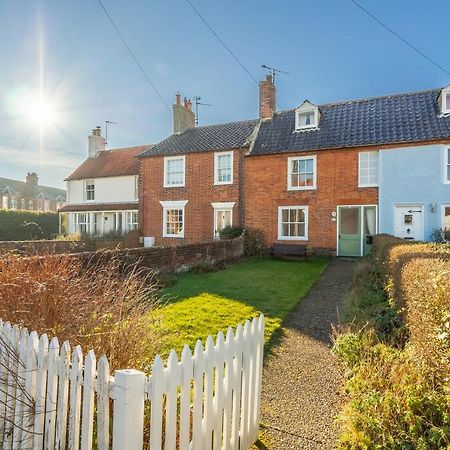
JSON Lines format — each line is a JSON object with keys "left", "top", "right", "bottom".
{"left": 251, "top": 89, "right": 450, "bottom": 155}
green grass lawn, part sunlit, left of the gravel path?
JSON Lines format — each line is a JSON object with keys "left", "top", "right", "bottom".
{"left": 152, "top": 258, "right": 328, "bottom": 356}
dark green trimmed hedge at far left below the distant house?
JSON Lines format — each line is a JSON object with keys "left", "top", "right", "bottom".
{"left": 0, "top": 210, "right": 59, "bottom": 241}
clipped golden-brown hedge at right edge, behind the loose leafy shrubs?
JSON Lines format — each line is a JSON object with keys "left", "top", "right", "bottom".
{"left": 373, "top": 235, "right": 450, "bottom": 380}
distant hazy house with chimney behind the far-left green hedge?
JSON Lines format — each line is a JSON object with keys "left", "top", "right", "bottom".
{"left": 0, "top": 172, "right": 66, "bottom": 212}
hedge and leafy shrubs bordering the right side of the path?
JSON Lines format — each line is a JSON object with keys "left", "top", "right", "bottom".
{"left": 334, "top": 235, "right": 450, "bottom": 450}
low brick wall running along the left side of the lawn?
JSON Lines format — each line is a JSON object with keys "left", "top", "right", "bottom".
{"left": 70, "top": 237, "right": 244, "bottom": 272}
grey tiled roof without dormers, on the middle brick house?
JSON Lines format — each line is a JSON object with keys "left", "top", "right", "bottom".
{"left": 140, "top": 119, "right": 258, "bottom": 157}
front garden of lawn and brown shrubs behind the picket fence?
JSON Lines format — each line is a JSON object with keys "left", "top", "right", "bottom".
{"left": 0, "top": 254, "right": 327, "bottom": 371}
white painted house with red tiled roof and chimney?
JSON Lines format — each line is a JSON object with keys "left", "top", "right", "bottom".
{"left": 59, "top": 127, "right": 151, "bottom": 236}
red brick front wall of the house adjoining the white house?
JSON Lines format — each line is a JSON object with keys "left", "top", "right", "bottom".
{"left": 139, "top": 149, "right": 248, "bottom": 246}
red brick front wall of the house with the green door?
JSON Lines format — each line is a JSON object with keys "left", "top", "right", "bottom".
{"left": 245, "top": 149, "right": 378, "bottom": 251}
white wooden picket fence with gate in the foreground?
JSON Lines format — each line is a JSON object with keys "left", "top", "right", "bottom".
{"left": 0, "top": 315, "right": 264, "bottom": 450}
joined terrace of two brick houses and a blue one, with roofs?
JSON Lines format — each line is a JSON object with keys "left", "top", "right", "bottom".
{"left": 139, "top": 76, "right": 450, "bottom": 256}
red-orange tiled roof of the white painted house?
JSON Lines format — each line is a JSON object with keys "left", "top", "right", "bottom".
{"left": 66, "top": 145, "right": 151, "bottom": 180}
